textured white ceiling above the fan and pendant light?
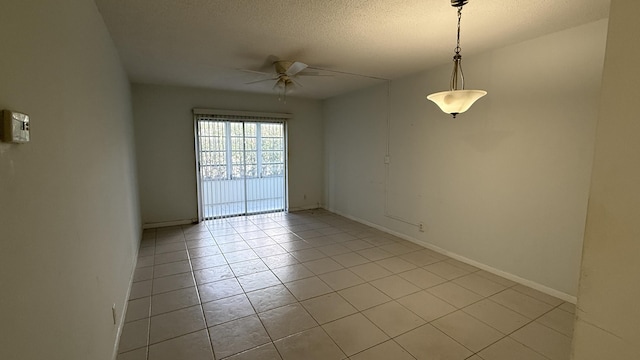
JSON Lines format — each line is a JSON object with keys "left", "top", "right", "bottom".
{"left": 95, "top": 0, "right": 610, "bottom": 99}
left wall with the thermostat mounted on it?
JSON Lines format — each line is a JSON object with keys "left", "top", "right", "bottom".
{"left": 0, "top": 0, "right": 140, "bottom": 360}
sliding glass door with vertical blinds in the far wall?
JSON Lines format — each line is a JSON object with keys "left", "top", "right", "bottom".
{"left": 196, "top": 115, "right": 287, "bottom": 219}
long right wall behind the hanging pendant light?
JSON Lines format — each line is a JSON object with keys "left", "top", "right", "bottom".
{"left": 324, "top": 20, "right": 607, "bottom": 299}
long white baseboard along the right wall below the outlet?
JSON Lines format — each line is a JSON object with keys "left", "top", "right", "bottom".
{"left": 325, "top": 208, "right": 577, "bottom": 304}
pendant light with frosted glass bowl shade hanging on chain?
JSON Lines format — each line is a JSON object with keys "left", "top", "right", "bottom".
{"left": 427, "top": 0, "right": 487, "bottom": 119}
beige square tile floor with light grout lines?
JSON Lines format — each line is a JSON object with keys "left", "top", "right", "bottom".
{"left": 118, "top": 210, "right": 574, "bottom": 360}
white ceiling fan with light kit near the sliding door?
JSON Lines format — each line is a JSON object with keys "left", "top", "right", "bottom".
{"left": 239, "top": 60, "right": 331, "bottom": 102}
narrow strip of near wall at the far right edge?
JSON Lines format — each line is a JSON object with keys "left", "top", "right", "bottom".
{"left": 572, "top": 0, "right": 640, "bottom": 360}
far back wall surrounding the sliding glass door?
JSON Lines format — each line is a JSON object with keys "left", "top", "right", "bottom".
{"left": 133, "top": 84, "right": 323, "bottom": 224}
